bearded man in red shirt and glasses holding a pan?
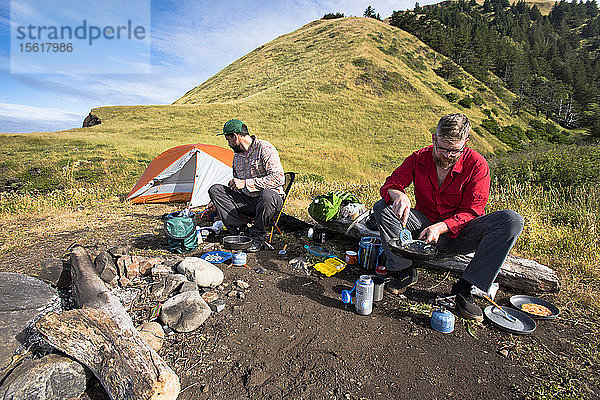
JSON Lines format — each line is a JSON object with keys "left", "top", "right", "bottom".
{"left": 373, "top": 114, "right": 523, "bottom": 321}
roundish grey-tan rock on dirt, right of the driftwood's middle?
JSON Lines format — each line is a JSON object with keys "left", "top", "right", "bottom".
{"left": 160, "top": 291, "right": 211, "bottom": 332}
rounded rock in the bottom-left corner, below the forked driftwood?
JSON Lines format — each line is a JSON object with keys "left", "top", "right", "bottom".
{"left": 0, "top": 354, "right": 87, "bottom": 400}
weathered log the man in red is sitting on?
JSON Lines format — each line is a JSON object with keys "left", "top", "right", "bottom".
{"left": 322, "top": 219, "right": 560, "bottom": 293}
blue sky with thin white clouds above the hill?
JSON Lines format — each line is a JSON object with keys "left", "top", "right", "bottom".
{"left": 0, "top": 0, "right": 436, "bottom": 133}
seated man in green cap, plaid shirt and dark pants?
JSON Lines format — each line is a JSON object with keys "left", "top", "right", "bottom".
{"left": 208, "top": 119, "right": 285, "bottom": 252}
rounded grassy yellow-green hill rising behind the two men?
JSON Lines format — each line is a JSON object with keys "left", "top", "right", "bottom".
{"left": 2, "top": 18, "right": 525, "bottom": 185}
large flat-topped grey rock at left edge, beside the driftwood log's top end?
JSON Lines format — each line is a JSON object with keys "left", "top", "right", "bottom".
{"left": 0, "top": 272, "right": 60, "bottom": 382}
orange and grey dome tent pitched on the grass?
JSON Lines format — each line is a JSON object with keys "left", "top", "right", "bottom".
{"left": 127, "top": 144, "right": 233, "bottom": 207}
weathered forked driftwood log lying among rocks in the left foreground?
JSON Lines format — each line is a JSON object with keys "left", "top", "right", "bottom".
{"left": 36, "top": 246, "right": 180, "bottom": 400}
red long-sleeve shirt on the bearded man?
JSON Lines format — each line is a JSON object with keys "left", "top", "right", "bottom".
{"left": 380, "top": 146, "right": 490, "bottom": 237}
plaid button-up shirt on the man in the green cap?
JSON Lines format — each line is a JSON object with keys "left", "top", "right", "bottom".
{"left": 233, "top": 136, "right": 285, "bottom": 196}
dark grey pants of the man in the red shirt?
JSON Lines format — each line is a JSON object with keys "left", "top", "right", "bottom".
{"left": 373, "top": 200, "right": 523, "bottom": 291}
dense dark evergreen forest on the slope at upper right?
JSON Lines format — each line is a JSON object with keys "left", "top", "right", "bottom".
{"left": 390, "top": 0, "right": 600, "bottom": 137}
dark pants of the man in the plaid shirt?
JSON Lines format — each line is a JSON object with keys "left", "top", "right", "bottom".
{"left": 208, "top": 184, "right": 283, "bottom": 240}
